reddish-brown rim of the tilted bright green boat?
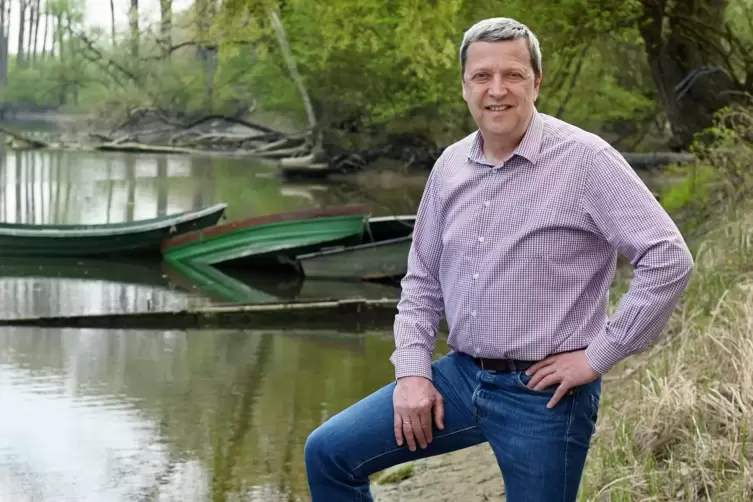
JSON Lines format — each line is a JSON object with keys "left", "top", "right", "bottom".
{"left": 160, "top": 204, "right": 370, "bottom": 254}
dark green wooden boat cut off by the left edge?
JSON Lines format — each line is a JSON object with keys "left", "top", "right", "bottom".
{"left": 0, "top": 204, "right": 227, "bottom": 258}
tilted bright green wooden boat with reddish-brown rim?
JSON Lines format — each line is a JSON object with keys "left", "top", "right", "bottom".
{"left": 162, "top": 205, "right": 369, "bottom": 269}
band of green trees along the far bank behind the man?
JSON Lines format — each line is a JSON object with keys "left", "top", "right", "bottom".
{"left": 0, "top": 0, "right": 753, "bottom": 149}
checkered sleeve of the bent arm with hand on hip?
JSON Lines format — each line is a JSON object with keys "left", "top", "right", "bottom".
{"left": 582, "top": 148, "right": 694, "bottom": 374}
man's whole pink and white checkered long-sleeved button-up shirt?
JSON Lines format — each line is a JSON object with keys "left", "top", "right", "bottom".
{"left": 390, "top": 112, "right": 693, "bottom": 379}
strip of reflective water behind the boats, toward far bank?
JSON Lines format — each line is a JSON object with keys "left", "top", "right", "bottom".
{"left": 0, "top": 145, "right": 422, "bottom": 224}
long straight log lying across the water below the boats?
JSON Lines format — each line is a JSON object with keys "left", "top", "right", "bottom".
{"left": 0, "top": 298, "right": 399, "bottom": 332}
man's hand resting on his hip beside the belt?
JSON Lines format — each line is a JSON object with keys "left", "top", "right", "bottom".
{"left": 526, "top": 350, "right": 601, "bottom": 408}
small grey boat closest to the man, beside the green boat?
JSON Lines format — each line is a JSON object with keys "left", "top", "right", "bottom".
{"left": 296, "top": 216, "right": 416, "bottom": 279}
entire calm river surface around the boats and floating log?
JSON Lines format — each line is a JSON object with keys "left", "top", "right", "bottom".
{"left": 0, "top": 130, "right": 443, "bottom": 502}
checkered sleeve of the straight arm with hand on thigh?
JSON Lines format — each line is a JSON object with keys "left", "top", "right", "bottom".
{"left": 390, "top": 157, "right": 444, "bottom": 380}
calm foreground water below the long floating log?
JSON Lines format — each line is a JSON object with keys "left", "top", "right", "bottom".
{"left": 0, "top": 329, "right": 440, "bottom": 502}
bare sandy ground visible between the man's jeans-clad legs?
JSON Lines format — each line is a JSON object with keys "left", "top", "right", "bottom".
{"left": 371, "top": 444, "right": 505, "bottom": 502}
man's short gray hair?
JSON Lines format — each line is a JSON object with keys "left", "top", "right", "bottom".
{"left": 460, "top": 17, "right": 541, "bottom": 78}
